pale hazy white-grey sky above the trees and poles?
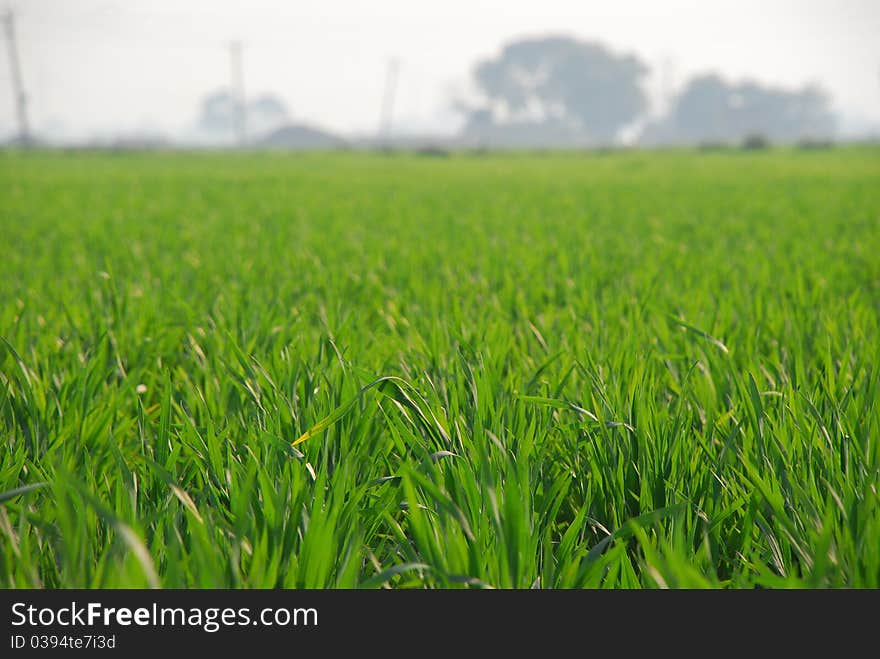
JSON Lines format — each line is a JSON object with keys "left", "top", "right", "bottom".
{"left": 0, "top": 0, "right": 880, "bottom": 141}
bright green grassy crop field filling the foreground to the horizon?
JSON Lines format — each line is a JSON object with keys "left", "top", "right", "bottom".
{"left": 0, "top": 148, "right": 880, "bottom": 588}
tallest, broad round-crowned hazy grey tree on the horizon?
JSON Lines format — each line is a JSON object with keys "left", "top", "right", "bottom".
{"left": 469, "top": 36, "right": 647, "bottom": 142}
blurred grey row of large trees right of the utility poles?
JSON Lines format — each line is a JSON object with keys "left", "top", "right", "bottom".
{"left": 459, "top": 36, "right": 834, "bottom": 146}
